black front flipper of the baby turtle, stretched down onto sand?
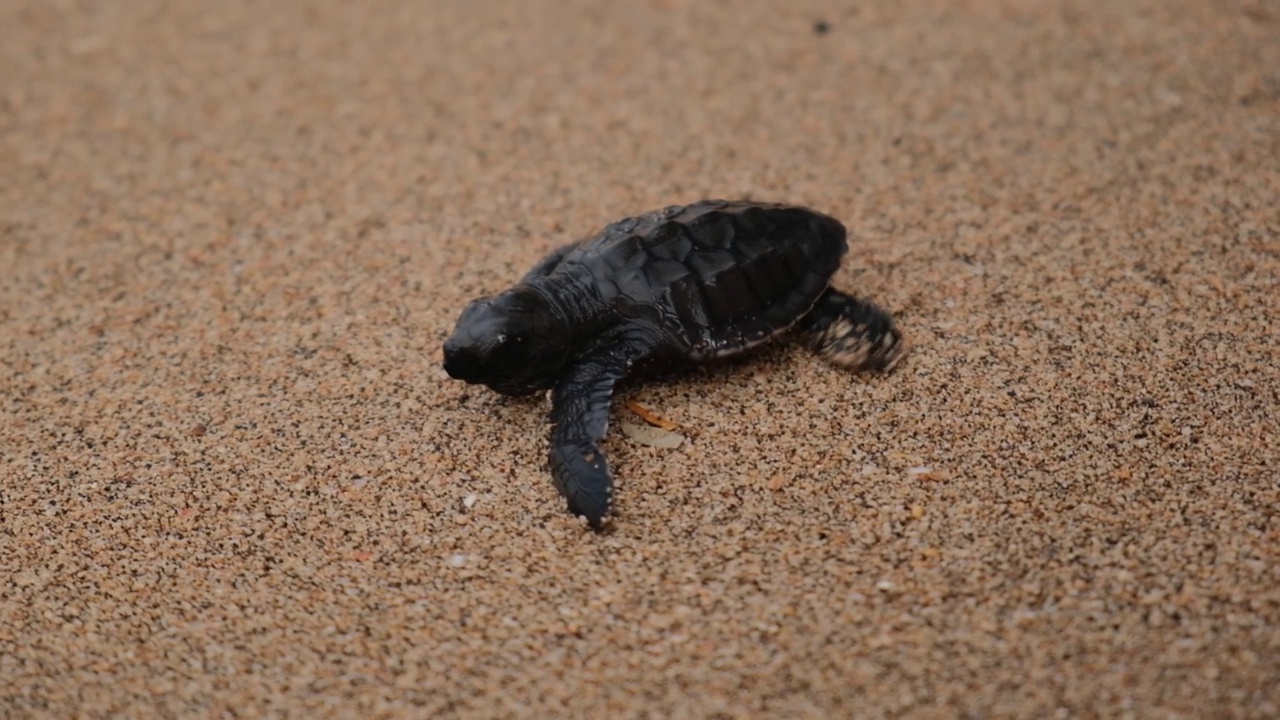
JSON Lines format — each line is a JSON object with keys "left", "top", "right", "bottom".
{"left": 549, "top": 331, "right": 657, "bottom": 530}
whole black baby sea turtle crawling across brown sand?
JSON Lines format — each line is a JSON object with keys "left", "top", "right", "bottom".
{"left": 444, "top": 200, "right": 905, "bottom": 529}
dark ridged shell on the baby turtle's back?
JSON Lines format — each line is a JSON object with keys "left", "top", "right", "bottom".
{"left": 557, "top": 200, "right": 847, "bottom": 360}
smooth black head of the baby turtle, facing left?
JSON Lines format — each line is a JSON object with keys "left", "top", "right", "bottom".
{"left": 444, "top": 286, "right": 570, "bottom": 396}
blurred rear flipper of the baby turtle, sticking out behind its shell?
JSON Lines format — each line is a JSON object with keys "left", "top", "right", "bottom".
{"left": 796, "top": 288, "right": 906, "bottom": 373}
